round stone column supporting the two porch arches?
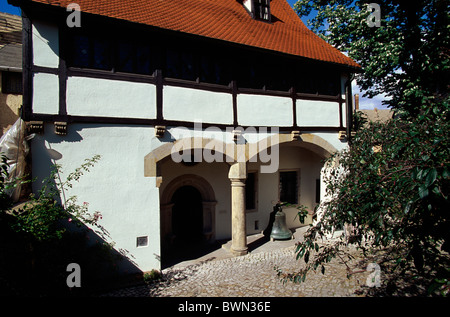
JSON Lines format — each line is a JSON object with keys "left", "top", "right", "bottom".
{"left": 228, "top": 162, "right": 248, "bottom": 255}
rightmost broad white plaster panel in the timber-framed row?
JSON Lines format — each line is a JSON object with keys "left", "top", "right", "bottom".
{"left": 296, "top": 100, "right": 345, "bottom": 127}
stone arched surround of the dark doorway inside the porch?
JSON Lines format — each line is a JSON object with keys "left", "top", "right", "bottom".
{"left": 160, "top": 174, "right": 217, "bottom": 244}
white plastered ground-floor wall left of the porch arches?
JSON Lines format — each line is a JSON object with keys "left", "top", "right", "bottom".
{"left": 32, "top": 124, "right": 160, "bottom": 271}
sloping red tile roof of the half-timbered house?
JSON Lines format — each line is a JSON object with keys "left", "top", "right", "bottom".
{"left": 24, "top": 0, "right": 360, "bottom": 68}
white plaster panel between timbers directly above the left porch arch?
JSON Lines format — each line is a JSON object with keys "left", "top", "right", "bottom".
{"left": 163, "top": 86, "right": 233, "bottom": 124}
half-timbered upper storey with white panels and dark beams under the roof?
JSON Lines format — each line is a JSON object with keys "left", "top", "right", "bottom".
{"left": 24, "top": 19, "right": 354, "bottom": 132}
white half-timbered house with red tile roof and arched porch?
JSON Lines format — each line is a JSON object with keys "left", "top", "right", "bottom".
{"left": 9, "top": 0, "right": 359, "bottom": 271}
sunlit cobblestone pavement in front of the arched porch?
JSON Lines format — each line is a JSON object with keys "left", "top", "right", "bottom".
{"left": 104, "top": 227, "right": 370, "bottom": 297}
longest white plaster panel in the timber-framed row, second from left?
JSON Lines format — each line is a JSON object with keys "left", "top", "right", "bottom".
{"left": 67, "top": 77, "right": 156, "bottom": 119}
